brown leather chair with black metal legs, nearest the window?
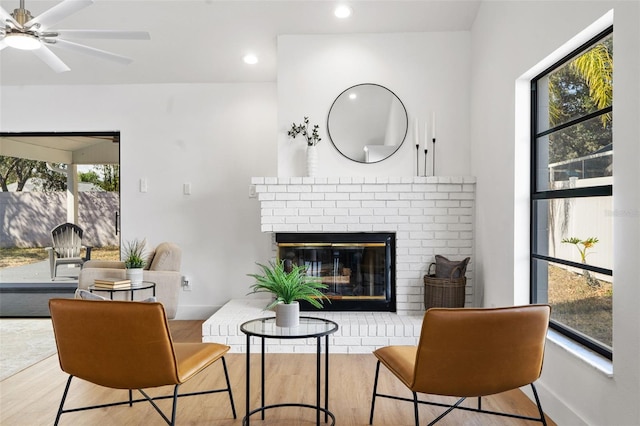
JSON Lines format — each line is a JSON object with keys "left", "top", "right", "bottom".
{"left": 369, "top": 305, "right": 551, "bottom": 426}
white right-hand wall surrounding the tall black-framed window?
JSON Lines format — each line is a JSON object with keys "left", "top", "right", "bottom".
{"left": 471, "top": 1, "right": 640, "bottom": 425}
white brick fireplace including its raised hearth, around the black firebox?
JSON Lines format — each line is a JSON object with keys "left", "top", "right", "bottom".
{"left": 203, "top": 176, "right": 476, "bottom": 353}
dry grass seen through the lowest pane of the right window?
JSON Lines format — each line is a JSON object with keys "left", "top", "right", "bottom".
{"left": 549, "top": 265, "right": 613, "bottom": 346}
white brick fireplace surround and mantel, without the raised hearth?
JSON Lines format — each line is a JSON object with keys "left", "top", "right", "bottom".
{"left": 251, "top": 176, "right": 476, "bottom": 315}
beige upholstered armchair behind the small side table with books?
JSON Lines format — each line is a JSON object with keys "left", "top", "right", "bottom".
{"left": 78, "top": 242, "right": 182, "bottom": 318}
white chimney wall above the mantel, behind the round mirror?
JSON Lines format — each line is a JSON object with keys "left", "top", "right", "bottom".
{"left": 278, "top": 32, "right": 470, "bottom": 177}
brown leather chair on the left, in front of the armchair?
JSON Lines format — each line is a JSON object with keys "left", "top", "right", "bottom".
{"left": 49, "top": 299, "right": 236, "bottom": 425}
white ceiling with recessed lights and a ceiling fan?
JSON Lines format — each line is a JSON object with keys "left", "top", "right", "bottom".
{"left": 0, "top": 0, "right": 481, "bottom": 85}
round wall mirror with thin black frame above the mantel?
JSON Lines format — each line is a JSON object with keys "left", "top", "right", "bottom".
{"left": 327, "top": 83, "right": 409, "bottom": 163}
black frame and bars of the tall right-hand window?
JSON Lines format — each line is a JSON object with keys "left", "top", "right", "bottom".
{"left": 529, "top": 26, "right": 615, "bottom": 360}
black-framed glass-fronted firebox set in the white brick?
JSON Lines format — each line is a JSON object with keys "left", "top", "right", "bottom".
{"left": 276, "top": 233, "right": 396, "bottom": 312}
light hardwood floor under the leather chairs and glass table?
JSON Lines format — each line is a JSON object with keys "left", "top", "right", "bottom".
{"left": 0, "top": 321, "right": 555, "bottom": 426}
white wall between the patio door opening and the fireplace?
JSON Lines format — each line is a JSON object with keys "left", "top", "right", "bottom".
{"left": 0, "top": 83, "right": 276, "bottom": 319}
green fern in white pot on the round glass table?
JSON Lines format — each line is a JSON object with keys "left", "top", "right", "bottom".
{"left": 247, "top": 260, "right": 329, "bottom": 327}
